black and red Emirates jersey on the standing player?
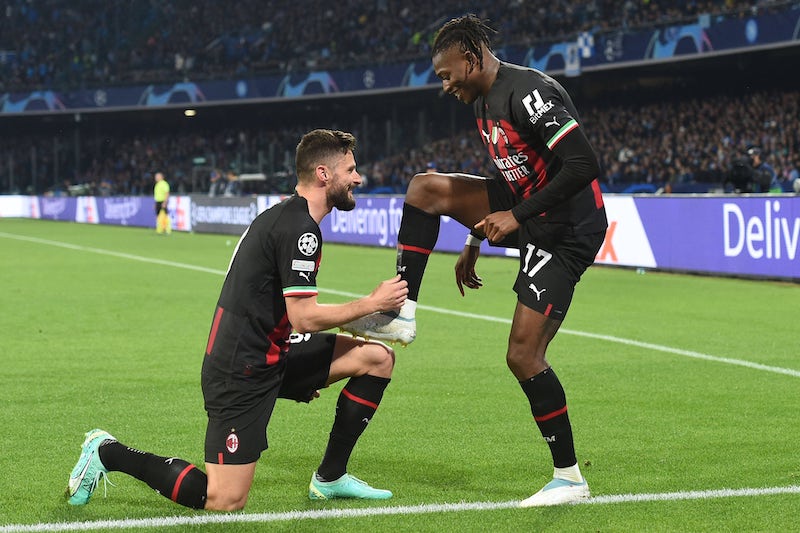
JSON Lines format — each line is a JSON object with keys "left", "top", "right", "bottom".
{"left": 473, "top": 62, "right": 607, "bottom": 233}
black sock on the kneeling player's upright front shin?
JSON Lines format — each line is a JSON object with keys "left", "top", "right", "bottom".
{"left": 317, "top": 374, "right": 391, "bottom": 481}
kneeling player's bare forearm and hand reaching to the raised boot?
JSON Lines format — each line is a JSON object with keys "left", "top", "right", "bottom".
{"left": 286, "top": 275, "right": 408, "bottom": 333}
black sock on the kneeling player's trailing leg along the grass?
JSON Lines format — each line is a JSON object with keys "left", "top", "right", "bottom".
{"left": 97, "top": 441, "right": 208, "bottom": 509}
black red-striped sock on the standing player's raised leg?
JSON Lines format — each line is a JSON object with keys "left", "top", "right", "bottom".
{"left": 397, "top": 204, "right": 439, "bottom": 302}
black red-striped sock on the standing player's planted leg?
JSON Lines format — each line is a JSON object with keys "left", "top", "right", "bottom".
{"left": 520, "top": 368, "right": 578, "bottom": 468}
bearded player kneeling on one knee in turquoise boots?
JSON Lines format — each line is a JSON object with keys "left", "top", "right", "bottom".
{"left": 67, "top": 130, "right": 408, "bottom": 511}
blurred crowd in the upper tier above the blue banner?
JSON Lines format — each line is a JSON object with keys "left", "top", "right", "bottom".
{"left": 0, "top": 0, "right": 780, "bottom": 92}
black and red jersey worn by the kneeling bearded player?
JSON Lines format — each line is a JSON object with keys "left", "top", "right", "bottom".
{"left": 212, "top": 196, "right": 322, "bottom": 364}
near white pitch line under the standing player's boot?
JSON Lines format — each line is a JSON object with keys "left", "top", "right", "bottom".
{"left": 0, "top": 485, "right": 800, "bottom": 533}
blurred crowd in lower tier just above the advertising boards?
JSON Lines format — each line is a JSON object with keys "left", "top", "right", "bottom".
{"left": 0, "top": 86, "right": 800, "bottom": 195}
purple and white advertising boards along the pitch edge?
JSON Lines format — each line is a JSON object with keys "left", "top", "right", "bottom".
{"left": 0, "top": 194, "right": 800, "bottom": 282}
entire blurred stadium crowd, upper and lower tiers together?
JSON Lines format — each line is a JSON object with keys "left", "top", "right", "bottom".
{"left": 0, "top": 0, "right": 800, "bottom": 195}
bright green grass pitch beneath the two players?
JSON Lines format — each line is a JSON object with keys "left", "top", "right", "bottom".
{"left": 0, "top": 219, "right": 800, "bottom": 533}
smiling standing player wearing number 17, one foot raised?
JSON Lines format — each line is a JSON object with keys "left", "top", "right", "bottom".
{"left": 342, "top": 14, "right": 607, "bottom": 507}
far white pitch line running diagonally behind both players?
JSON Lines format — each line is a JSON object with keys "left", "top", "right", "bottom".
{"left": 0, "top": 232, "right": 800, "bottom": 378}
